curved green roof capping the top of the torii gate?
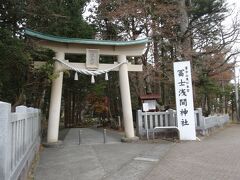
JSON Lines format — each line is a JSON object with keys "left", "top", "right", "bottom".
{"left": 25, "top": 29, "right": 149, "bottom": 46}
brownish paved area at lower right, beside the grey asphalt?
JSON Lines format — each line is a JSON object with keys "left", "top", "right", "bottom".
{"left": 145, "top": 125, "right": 240, "bottom": 180}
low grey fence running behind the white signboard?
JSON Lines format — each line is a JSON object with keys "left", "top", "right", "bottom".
{"left": 137, "top": 108, "right": 229, "bottom": 137}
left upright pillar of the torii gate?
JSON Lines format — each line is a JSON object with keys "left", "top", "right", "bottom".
{"left": 47, "top": 52, "right": 65, "bottom": 143}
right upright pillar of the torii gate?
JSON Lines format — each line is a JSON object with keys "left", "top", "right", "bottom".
{"left": 118, "top": 55, "right": 135, "bottom": 139}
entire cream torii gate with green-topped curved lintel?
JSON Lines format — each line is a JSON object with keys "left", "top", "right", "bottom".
{"left": 25, "top": 29, "right": 148, "bottom": 143}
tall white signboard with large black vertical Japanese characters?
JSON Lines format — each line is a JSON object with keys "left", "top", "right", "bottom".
{"left": 174, "top": 61, "right": 196, "bottom": 140}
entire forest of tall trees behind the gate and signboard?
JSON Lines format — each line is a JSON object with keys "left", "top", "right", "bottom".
{"left": 0, "top": 0, "right": 240, "bottom": 126}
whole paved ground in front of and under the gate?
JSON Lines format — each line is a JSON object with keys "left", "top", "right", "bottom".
{"left": 35, "top": 125, "right": 240, "bottom": 180}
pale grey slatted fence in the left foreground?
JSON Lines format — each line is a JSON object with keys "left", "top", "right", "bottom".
{"left": 0, "top": 101, "right": 40, "bottom": 180}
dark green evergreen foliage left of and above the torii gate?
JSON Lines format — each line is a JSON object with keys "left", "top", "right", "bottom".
{"left": 0, "top": 0, "right": 94, "bottom": 107}
